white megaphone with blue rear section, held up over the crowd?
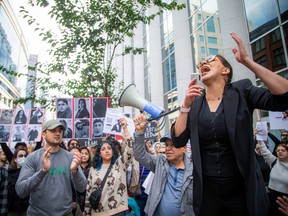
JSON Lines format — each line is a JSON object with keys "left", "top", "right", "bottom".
{"left": 118, "top": 84, "right": 164, "bottom": 121}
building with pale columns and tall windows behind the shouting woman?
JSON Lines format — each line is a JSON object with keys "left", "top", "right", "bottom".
{"left": 114, "top": 0, "right": 288, "bottom": 134}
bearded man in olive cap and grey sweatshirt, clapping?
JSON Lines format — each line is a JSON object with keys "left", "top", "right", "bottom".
{"left": 16, "top": 120, "right": 87, "bottom": 216}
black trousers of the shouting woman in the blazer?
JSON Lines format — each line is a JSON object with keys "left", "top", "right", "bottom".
{"left": 200, "top": 176, "right": 249, "bottom": 216}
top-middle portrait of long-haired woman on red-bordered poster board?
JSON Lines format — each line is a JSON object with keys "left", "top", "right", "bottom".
{"left": 74, "top": 98, "right": 90, "bottom": 118}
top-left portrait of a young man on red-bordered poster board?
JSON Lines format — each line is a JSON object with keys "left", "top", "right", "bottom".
{"left": 56, "top": 98, "right": 72, "bottom": 119}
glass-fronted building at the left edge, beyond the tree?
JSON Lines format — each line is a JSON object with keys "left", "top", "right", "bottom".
{"left": 0, "top": 0, "right": 29, "bottom": 109}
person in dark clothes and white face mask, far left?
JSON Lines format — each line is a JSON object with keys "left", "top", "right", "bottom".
{"left": 8, "top": 148, "right": 29, "bottom": 215}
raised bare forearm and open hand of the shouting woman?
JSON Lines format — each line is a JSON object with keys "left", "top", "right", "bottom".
{"left": 230, "top": 32, "right": 288, "bottom": 95}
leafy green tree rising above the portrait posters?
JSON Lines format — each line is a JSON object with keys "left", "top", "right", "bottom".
{"left": 20, "top": 0, "right": 185, "bottom": 108}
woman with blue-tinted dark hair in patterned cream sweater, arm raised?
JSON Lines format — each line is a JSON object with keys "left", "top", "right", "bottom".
{"left": 84, "top": 118, "right": 133, "bottom": 216}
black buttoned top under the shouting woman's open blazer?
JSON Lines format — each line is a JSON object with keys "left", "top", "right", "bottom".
{"left": 198, "top": 100, "right": 240, "bottom": 177}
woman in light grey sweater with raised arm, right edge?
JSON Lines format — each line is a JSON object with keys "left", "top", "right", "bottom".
{"left": 257, "top": 141, "right": 288, "bottom": 216}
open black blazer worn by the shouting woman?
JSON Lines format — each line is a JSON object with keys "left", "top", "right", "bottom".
{"left": 171, "top": 79, "right": 288, "bottom": 216}
